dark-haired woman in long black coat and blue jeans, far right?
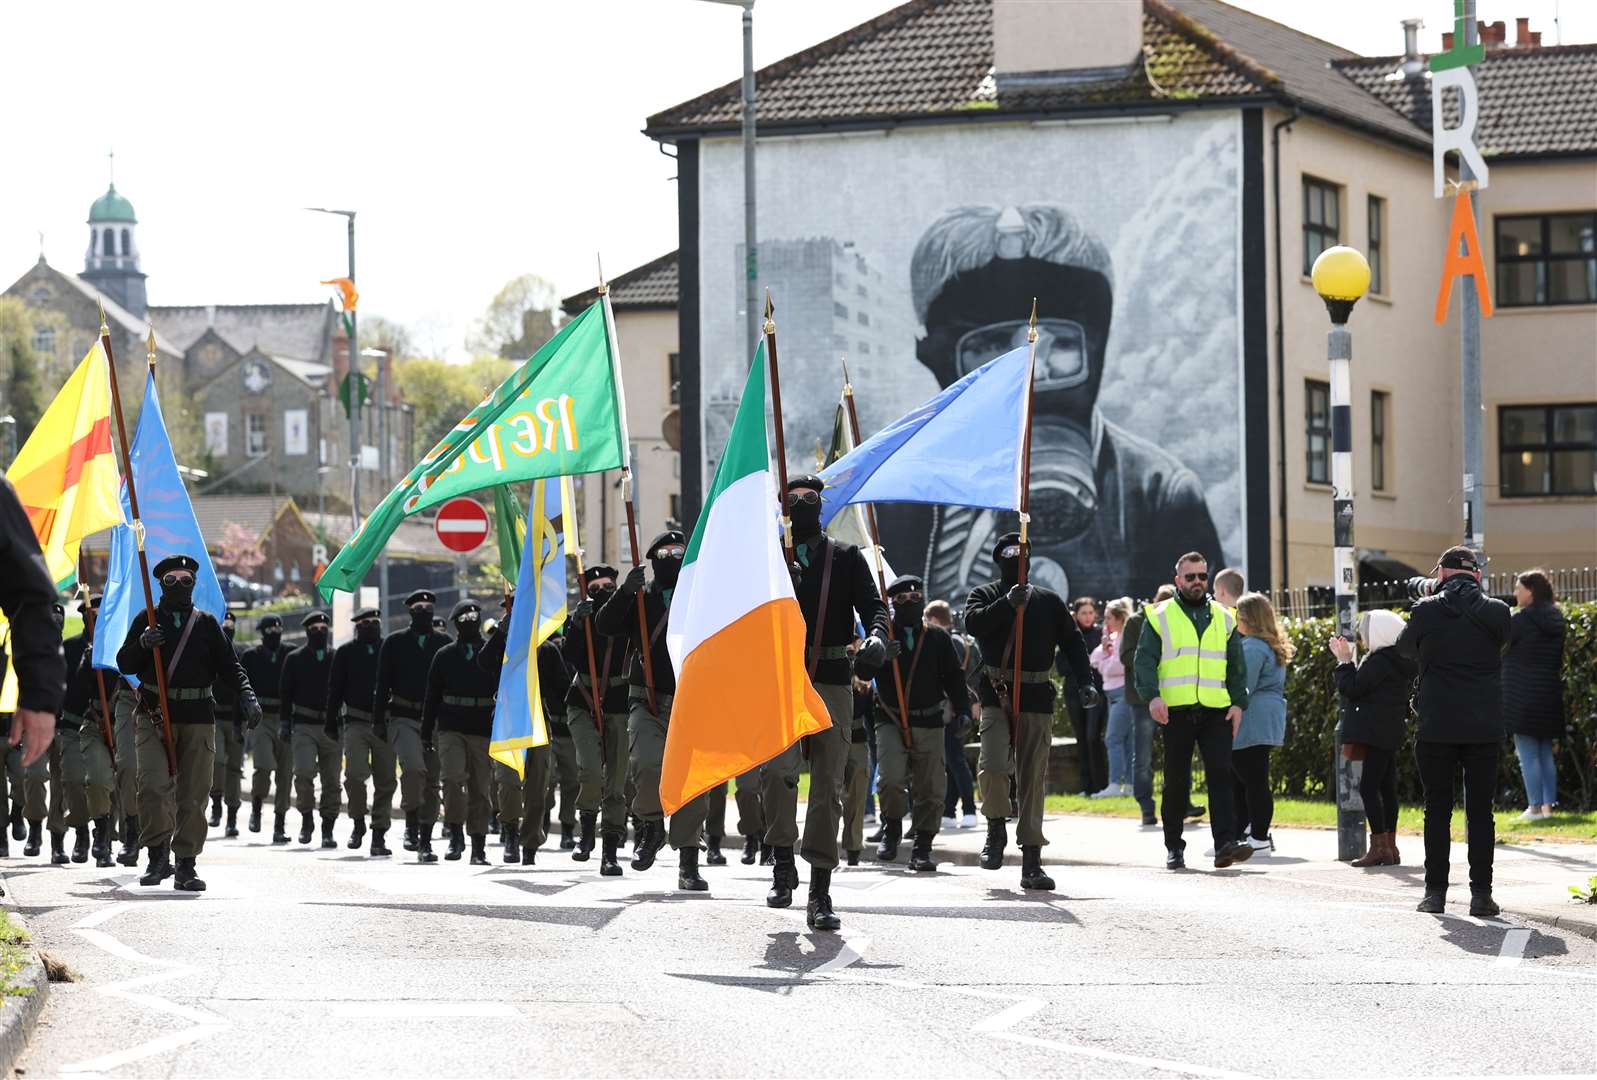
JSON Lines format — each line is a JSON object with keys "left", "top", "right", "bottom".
{"left": 1503, "top": 570, "right": 1565, "bottom": 821}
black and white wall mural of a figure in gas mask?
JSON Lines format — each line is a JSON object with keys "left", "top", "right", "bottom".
{"left": 699, "top": 115, "right": 1246, "bottom": 606}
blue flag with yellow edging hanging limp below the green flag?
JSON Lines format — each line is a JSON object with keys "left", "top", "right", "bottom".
{"left": 489, "top": 476, "right": 577, "bottom": 776}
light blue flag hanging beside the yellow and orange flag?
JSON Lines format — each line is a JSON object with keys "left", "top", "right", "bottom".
{"left": 94, "top": 371, "right": 227, "bottom": 685}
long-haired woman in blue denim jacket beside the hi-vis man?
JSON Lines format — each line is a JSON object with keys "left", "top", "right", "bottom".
{"left": 1231, "top": 593, "right": 1295, "bottom": 852}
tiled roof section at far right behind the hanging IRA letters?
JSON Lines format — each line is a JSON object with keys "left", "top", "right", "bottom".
{"left": 1335, "top": 45, "right": 1597, "bottom": 158}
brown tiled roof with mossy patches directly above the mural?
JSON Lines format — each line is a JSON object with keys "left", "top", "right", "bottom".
{"left": 645, "top": 0, "right": 1425, "bottom": 144}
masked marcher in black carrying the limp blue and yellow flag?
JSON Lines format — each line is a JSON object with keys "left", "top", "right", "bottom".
{"left": 565, "top": 564, "right": 636, "bottom": 877}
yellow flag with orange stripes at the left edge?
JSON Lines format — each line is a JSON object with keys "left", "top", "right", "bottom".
{"left": 6, "top": 340, "right": 123, "bottom": 590}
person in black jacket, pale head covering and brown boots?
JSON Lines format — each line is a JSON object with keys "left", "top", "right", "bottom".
{"left": 1329, "top": 610, "right": 1415, "bottom": 866}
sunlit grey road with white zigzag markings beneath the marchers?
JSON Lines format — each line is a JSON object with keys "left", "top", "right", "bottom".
{"left": 0, "top": 805, "right": 1597, "bottom": 1080}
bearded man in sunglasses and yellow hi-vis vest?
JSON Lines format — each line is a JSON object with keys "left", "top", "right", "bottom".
{"left": 1134, "top": 551, "right": 1254, "bottom": 871}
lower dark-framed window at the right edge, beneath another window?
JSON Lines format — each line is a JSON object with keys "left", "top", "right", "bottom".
{"left": 1498, "top": 404, "right": 1597, "bottom": 498}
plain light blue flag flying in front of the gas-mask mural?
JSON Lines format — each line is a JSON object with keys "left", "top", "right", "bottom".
{"left": 821, "top": 345, "right": 1030, "bottom": 526}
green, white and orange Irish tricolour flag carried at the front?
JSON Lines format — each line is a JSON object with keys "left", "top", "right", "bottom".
{"left": 660, "top": 342, "right": 830, "bottom": 813}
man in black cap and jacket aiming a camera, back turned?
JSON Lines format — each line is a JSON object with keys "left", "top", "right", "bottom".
{"left": 1394, "top": 548, "right": 1509, "bottom": 915}
